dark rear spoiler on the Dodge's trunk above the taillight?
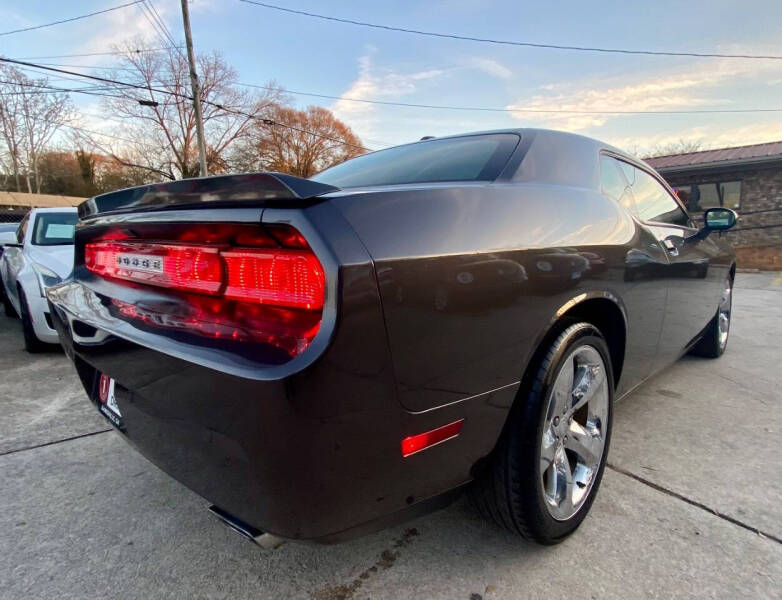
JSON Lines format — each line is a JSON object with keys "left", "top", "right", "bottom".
{"left": 79, "top": 172, "right": 340, "bottom": 219}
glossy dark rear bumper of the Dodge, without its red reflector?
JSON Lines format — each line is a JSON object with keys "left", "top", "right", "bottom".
{"left": 53, "top": 286, "right": 515, "bottom": 541}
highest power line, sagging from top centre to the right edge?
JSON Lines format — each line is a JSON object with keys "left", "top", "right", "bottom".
{"left": 239, "top": 0, "right": 782, "bottom": 60}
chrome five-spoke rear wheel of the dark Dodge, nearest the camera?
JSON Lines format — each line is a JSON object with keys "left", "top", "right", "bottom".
{"left": 540, "top": 345, "right": 610, "bottom": 521}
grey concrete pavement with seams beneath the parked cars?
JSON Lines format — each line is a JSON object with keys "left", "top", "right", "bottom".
{"left": 0, "top": 274, "right": 782, "bottom": 600}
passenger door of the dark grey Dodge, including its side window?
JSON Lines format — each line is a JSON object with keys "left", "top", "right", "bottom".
{"left": 623, "top": 163, "right": 723, "bottom": 368}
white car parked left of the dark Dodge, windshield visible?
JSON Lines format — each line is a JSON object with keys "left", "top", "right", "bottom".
{"left": 0, "top": 208, "right": 79, "bottom": 352}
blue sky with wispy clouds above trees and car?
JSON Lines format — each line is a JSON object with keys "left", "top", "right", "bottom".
{"left": 0, "top": 0, "right": 782, "bottom": 154}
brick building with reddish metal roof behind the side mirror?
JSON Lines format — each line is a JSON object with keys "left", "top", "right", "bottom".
{"left": 646, "top": 141, "right": 782, "bottom": 269}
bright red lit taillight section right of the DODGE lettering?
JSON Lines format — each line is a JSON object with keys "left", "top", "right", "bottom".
{"left": 222, "top": 249, "right": 325, "bottom": 310}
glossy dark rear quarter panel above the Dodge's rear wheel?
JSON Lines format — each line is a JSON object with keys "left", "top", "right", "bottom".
{"left": 333, "top": 184, "right": 665, "bottom": 412}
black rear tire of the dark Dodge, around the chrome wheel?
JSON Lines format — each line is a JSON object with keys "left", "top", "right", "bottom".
{"left": 470, "top": 323, "right": 614, "bottom": 545}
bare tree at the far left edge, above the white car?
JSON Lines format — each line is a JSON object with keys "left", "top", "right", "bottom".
{"left": 0, "top": 65, "right": 72, "bottom": 193}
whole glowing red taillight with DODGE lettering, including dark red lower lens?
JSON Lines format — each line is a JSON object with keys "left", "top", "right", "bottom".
{"left": 84, "top": 224, "right": 326, "bottom": 356}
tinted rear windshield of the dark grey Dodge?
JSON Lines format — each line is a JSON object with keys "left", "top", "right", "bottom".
{"left": 312, "top": 133, "right": 519, "bottom": 188}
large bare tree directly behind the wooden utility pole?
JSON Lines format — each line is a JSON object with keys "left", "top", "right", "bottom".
{"left": 91, "top": 43, "right": 284, "bottom": 179}
